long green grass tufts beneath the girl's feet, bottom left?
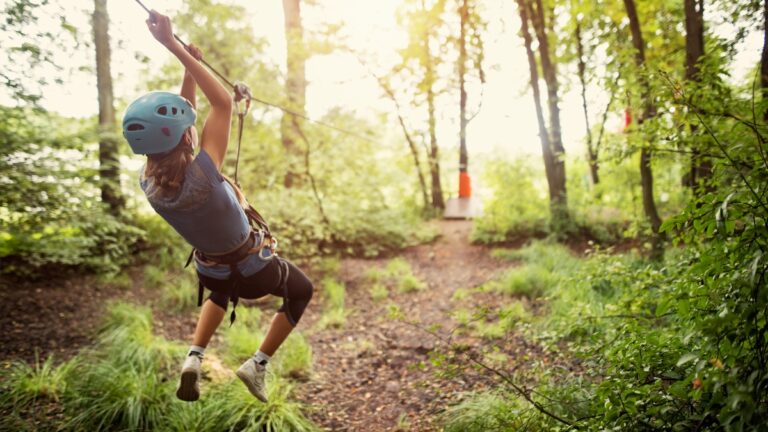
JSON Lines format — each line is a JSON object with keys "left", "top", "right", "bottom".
{"left": 0, "top": 303, "right": 318, "bottom": 431}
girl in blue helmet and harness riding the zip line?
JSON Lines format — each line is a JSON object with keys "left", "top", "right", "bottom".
{"left": 123, "top": 11, "right": 313, "bottom": 402}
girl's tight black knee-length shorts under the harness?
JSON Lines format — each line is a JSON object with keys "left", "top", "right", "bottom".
{"left": 197, "top": 257, "right": 314, "bottom": 326}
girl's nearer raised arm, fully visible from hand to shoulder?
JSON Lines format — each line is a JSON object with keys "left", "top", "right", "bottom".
{"left": 147, "top": 10, "right": 232, "bottom": 169}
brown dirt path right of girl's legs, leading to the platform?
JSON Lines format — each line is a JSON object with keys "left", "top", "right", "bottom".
{"left": 301, "top": 221, "right": 510, "bottom": 431}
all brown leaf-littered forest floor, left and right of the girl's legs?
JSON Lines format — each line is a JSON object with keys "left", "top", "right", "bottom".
{"left": 0, "top": 221, "right": 564, "bottom": 431}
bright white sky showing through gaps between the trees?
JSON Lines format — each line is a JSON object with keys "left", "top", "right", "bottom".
{"left": 0, "top": 0, "right": 762, "bottom": 171}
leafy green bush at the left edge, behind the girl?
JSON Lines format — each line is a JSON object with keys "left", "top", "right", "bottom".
{"left": 0, "top": 107, "right": 149, "bottom": 278}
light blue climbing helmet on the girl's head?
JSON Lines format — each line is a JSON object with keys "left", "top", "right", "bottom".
{"left": 123, "top": 92, "right": 197, "bottom": 154}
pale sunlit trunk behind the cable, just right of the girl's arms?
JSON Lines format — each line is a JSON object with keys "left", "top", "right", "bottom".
{"left": 280, "top": 0, "right": 307, "bottom": 188}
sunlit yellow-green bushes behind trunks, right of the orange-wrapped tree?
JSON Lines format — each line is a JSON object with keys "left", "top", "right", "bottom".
{"left": 472, "top": 152, "right": 690, "bottom": 244}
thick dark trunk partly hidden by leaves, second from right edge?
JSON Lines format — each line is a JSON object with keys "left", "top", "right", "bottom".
{"left": 684, "top": 0, "right": 712, "bottom": 194}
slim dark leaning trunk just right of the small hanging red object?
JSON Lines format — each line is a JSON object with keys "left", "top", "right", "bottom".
{"left": 624, "top": 0, "right": 664, "bottom": 257}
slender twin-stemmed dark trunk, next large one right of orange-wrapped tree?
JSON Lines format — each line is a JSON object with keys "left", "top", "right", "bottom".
{"left": 528, "top": 0, "right": 570, "bottom": 229}
